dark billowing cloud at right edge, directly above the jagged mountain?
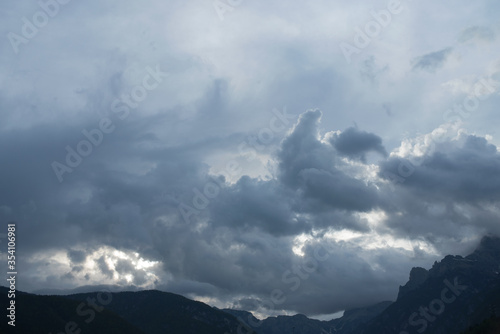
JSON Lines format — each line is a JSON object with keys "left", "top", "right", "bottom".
{"left": 380, "top": 134, "right": 500, "bottom": 245}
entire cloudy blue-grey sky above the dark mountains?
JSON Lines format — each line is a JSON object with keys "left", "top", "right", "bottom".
{"left": 0, "top": 0, "right": 500, "bottom": 317}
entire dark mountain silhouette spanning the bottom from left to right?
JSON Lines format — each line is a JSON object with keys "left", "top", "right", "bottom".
{"left": 0, "top": 237, "right": 500, "bottom": 334}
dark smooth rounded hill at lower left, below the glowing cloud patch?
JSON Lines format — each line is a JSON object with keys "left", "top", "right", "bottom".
{"left": 0, "top": 287, "right": 252, "bottom": 334}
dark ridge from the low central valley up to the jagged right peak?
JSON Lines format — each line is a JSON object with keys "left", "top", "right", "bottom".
{"left": 224, "top": 237, "right": 500, "bottom": 334}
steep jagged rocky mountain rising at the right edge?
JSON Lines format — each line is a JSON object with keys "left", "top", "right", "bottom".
{"left": 360, "top": 237, "right": 500, "bottom": 334}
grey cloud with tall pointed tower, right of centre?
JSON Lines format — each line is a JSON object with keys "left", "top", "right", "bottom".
{"left": 209, "top": 110, "right": 378, "bottom": 236}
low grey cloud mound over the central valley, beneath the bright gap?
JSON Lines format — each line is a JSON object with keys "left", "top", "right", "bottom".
{"left": 233, "top": 237, "right": 410, "bottom": 314}
